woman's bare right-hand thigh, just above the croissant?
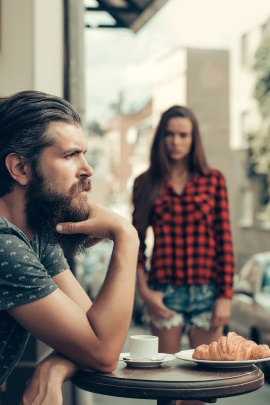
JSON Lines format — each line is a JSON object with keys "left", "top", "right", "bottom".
{"left": 181, "top": 327, "right": 223, "bottom": 405}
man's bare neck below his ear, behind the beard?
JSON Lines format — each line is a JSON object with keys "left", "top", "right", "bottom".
{"left": 0, "top": 189, "right": 34, "bottom": 240}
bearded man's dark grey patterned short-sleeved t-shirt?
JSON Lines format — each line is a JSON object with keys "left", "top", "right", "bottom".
{"left": 0, "top": 217, "right": 68, "bottom": 385}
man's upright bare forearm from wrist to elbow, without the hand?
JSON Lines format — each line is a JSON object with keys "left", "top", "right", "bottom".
{"left": 87, "top": 228, "right": 139, "bottom": 350}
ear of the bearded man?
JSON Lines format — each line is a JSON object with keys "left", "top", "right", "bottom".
{"left": 5, "top": 153, "right": 31, "bottom": 186}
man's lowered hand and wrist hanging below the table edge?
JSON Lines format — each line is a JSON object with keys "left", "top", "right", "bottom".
{"left": 20, "top": 353, "right": 79, "bottom": 405}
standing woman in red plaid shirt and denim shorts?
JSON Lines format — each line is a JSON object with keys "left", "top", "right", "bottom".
{"left": 133, "top": 106, "right": 235, "bottom": 403}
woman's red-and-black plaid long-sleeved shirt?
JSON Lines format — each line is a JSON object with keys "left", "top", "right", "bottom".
{"left": 133, "top": 169, "right": 235, "bottom": 298}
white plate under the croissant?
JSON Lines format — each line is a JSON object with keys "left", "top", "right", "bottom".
{"left": 174, "top": 349, "right": 270, "bottom": 368}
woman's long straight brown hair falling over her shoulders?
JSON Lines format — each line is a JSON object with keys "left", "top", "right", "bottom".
{"left": 133, "top": 105, "right": 209, "bottom": 235}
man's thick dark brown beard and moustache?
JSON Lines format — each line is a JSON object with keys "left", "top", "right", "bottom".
{"left": 25, "top": 174, "right": 93, "bottom": 258}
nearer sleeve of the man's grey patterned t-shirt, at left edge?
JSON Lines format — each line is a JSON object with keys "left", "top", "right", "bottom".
{"left": 0, "top": 234, "right": 57, "bottom": 311}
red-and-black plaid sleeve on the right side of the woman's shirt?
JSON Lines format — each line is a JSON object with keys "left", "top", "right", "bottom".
{"left": 213, "top": 172, "right": 235, "bottom": 298}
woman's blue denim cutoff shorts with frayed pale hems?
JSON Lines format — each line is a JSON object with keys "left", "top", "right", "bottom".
{"left": 143, "top": 283, "right": 216, "bottom": 331}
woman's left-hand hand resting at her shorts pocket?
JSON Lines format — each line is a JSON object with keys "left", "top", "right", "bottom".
{"left": 142, "top": 289, "right": 176, "bottom": 319}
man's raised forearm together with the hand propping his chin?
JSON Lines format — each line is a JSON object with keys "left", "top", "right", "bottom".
{"left": 53, "top": 204, "right": 139, "bottom": 372}
